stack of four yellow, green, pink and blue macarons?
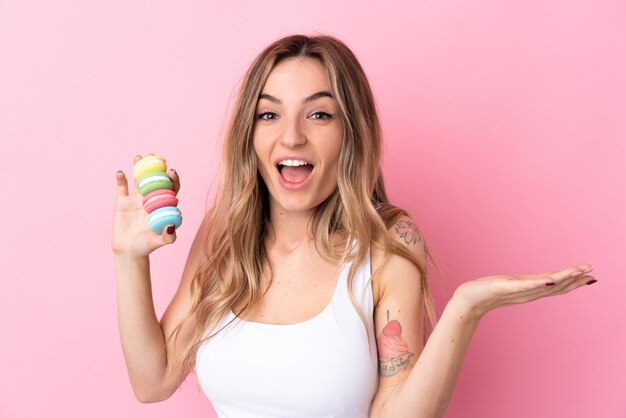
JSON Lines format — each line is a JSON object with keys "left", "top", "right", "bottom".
{"left": 134, "top": 155, "right": 183, "bottom": 234}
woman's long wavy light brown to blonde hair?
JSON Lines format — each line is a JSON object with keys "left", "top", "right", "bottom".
{"left": 168, "top": 35, "right": 436, "bottom": 371}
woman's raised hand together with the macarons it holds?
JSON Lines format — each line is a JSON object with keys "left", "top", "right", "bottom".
{"left": 112, "top": 154, "right": 182, "bottom": 257}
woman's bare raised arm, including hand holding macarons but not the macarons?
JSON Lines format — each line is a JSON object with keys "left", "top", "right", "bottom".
{"left": 112, "top": 157, "right": 201, "bottom": 402}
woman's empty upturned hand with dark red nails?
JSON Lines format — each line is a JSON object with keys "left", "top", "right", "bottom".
{"left": 455, "top": 263, "right": 595, "bottom": 317}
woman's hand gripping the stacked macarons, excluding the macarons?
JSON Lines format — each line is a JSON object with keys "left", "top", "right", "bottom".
{"left": 112, "top": 155, "right": 180, "bottom": 257}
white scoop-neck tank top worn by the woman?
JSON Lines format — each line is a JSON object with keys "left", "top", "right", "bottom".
{"left": 196, "top": 247, "right": 378, "bottom": 418}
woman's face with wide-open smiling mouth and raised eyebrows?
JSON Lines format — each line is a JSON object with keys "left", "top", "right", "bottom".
{"left": 253, "top": 58, "right": 343, "bottom": 216}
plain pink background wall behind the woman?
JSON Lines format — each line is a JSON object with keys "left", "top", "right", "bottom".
{"left": 0, "top": 0, "right": 626, "bottom": 418}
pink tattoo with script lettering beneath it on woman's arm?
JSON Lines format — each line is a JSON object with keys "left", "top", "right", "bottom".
{"left": 376, "top": 311, "right": 415, "bottom": 376}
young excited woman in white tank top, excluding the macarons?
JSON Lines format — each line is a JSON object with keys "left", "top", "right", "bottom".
{"left": 112, "top": 36, "right": 594, "bottom": 418}
